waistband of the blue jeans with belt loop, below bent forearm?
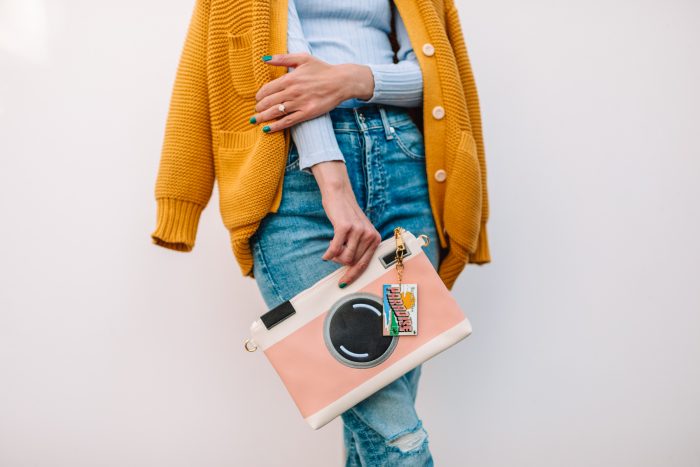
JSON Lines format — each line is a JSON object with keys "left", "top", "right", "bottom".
{"left": 329, "top": 103, "right": 411, "bottom": 139}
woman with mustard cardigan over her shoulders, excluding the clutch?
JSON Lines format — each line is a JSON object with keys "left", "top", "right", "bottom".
{"left": 151, "top": 0, "right": 490, "bottom": 466}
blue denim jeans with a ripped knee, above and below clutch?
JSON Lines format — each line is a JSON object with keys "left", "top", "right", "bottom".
{"left": 250, "top": 104, "right": 440, "bottom": 467}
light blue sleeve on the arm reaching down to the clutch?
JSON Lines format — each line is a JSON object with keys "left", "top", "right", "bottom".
{"left": 287, "top": 0, "right": 345, "bottom": 174}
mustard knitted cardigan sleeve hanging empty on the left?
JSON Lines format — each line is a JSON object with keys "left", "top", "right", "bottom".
{"left": 151, "top": 0, "right": 215, "bottom": 252}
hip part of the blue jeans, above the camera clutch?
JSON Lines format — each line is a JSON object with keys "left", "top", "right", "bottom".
{"left": 251, "top": 104, "right": 439, "bottom": 307}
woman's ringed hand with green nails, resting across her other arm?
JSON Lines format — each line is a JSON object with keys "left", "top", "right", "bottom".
{"left": 254, "top": 52, "right": 374, "bottom": 132}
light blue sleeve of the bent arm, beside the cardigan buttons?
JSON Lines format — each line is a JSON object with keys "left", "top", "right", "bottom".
{"left": 357, "top": 2, "right": 423, "bottom": 107}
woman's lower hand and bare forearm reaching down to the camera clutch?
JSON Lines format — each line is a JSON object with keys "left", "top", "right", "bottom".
{"left": 311, "top": 161, "right": 381, "bottom": 288}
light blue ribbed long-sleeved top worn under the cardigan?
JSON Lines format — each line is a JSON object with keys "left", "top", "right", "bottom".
{"left": 287, "top": 0, "right": 423, "bottom": 173}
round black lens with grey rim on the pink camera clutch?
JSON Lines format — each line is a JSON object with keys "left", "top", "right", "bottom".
{"left": 323, "top": 292, "right": 398, "bottom": 368}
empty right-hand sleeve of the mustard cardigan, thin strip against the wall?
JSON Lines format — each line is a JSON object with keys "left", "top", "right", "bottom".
{"left": 445, "top": 0, "right": 491, "bottom": 264}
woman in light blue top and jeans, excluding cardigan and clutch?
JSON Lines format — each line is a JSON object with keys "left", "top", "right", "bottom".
{"left": 251, "top": 0, "right": 439, "bottom": 466}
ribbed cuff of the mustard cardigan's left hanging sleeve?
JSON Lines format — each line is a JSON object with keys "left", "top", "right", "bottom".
{"left": 151, "top": 198, "right": 204, "bottom": 252}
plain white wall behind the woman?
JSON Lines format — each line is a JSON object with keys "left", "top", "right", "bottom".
{"left": 0, "top": 0, "right": 700, "bottom": 467}
